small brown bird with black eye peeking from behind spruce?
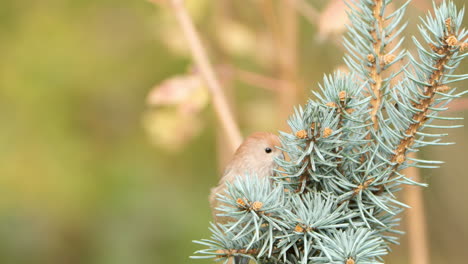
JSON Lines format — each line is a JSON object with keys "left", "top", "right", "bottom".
{"left": 210, "top": 132, "right": 283, "bottom": 224}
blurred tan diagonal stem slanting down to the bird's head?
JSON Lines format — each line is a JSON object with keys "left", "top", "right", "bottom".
{"left": 163, "top": 0, "right": 242, "bottom": 152}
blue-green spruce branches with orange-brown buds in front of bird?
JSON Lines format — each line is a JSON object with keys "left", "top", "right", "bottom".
{"left": 194, "top": 0, "right": 468, "bottom": 264}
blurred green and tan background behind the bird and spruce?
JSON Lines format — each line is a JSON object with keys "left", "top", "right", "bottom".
{"left": 0, "top": 0, "right": 468, "bottom": 264}
